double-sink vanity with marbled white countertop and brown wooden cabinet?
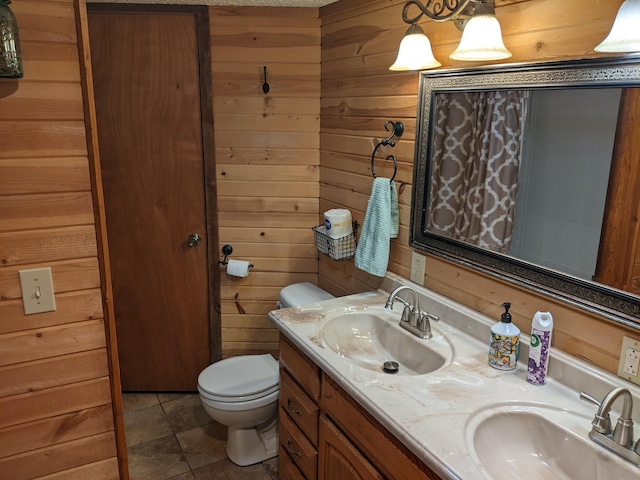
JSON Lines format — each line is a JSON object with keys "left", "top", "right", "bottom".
{"left": 270, "top": 274, "right": 640, "bottom": 480}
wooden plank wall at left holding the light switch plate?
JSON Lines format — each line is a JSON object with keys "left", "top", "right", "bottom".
{"left": 0, "top": 0, "right": 119, "bottom": 480}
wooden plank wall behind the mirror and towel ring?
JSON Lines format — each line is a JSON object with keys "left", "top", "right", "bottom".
{"left": 319, "top": 0, "right": 637, "bottom": 372}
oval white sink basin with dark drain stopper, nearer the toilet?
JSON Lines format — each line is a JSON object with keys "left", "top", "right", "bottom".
{"left": 320, "top": 308, "right": 453, "bottom": 375}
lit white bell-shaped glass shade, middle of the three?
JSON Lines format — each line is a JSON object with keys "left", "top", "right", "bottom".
{"left": 449, "top": 14, "right": 511, "bottom": 62}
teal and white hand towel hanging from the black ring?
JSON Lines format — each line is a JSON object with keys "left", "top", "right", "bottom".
{"left": 354, "top": 178, "right": 399, "bottom": 277}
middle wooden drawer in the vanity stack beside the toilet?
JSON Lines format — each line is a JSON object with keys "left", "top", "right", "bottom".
{"left": 280, "top": 370, "right": 319, "bottom": 447}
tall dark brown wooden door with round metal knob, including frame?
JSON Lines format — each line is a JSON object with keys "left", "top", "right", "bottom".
{"left": 89, "top": 5, "right": 220, "bottom": 391}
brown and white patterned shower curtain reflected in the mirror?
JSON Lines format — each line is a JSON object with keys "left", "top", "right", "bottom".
{"left": 427, "top": 91, "right": 528, "bottom": 253}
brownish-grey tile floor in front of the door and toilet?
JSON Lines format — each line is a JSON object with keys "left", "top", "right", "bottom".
{"left": 123, "top": 393, "right": 278, "bottom": 480}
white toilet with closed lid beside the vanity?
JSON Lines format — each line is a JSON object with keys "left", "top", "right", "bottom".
{"left": 198, "top": 282, "right": 334, "bottom": 466}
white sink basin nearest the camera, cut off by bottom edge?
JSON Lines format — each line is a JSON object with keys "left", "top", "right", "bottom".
{"left": 466, "top": 405, "right": 640, "bottom": 480}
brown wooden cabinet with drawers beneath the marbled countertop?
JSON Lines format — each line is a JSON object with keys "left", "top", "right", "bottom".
{"left": 279, "top": 334, "right": 440, "bottom": 480}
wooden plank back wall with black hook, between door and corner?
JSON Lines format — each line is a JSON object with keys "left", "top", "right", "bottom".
{"left": 210, "top": 7, "right": 320, "bottom": 357}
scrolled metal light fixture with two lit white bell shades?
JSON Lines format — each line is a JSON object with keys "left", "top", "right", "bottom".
{"left": 389, "top": 0, "right": 511, "bottom": 71}
